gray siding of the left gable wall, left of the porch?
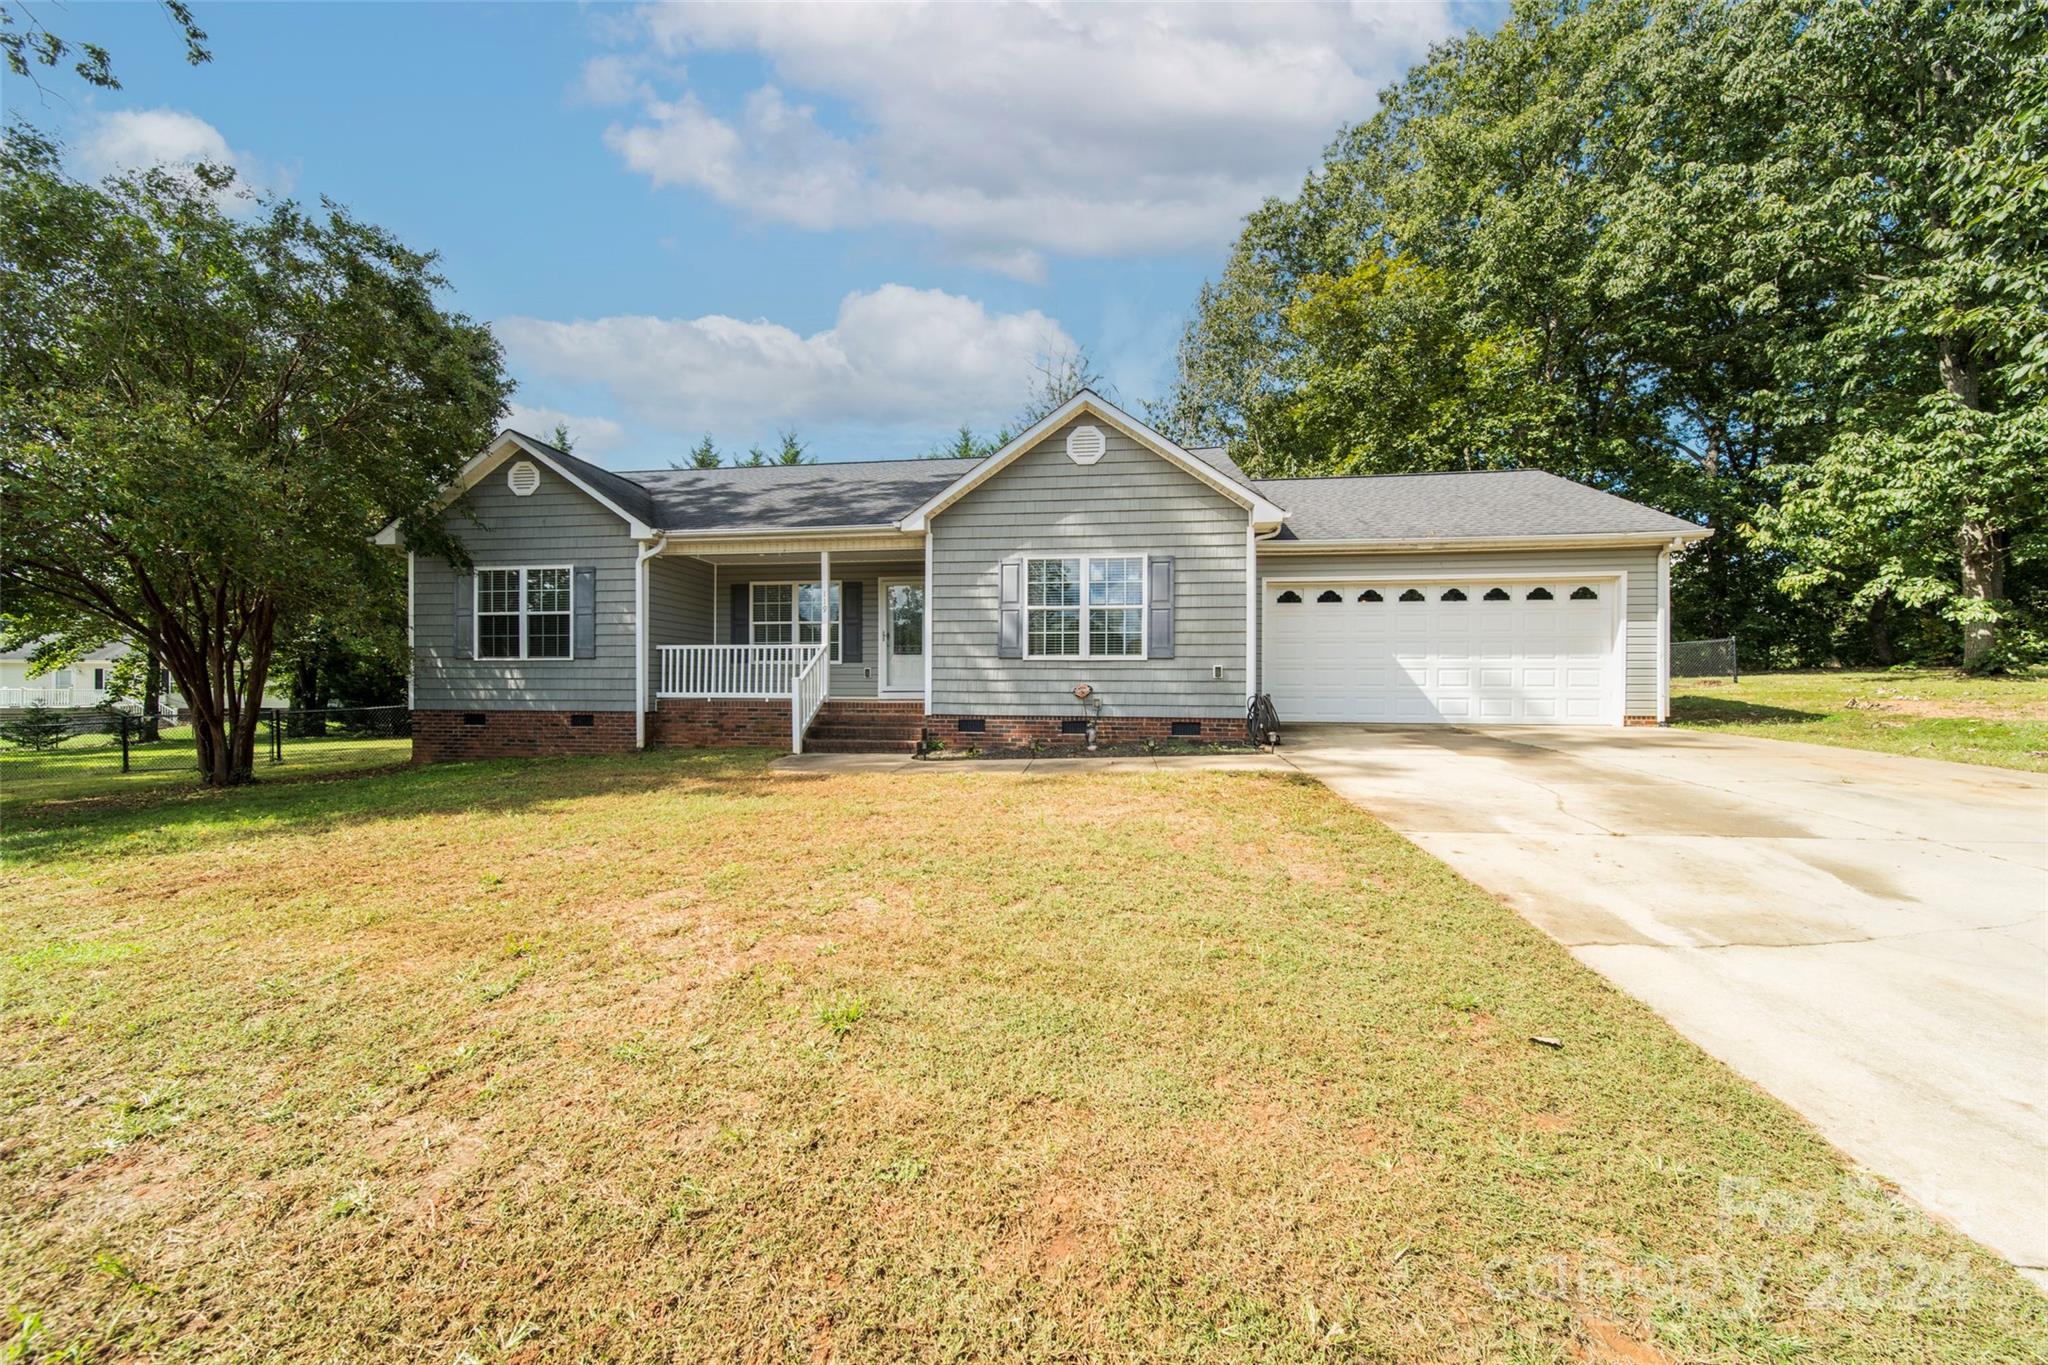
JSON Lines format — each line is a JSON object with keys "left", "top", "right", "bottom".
{"left": 412, "top": 469, "right": 635, "bottom": 710}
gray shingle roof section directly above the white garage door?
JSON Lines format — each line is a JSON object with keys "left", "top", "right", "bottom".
{"left": 1253, "top": 469, "right": 1700, "bottom": 542}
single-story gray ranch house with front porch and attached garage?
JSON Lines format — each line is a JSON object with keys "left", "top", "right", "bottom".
{"left": 379, "top": 393, "right": 1710, "bottom": 761}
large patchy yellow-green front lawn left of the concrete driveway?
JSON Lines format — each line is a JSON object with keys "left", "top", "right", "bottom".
{"left": 0, "top": 751, "right": 2048, "bottom": 1363}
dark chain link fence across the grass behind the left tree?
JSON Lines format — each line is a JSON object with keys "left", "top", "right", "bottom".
{"left": 0, "top": 706, "right": 412, "bottom": 800}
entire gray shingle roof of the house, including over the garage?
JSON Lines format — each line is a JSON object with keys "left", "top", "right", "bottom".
{"left": 503, "top": 432, "right": 1700, "bottom": 542}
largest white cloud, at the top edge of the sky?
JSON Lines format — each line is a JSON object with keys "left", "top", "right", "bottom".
{"left": 586, "top": 0, "right": 1450, "bottom": 261}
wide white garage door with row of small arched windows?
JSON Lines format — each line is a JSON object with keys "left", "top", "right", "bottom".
{"left": 1264, "top": 577, "right": 1622, "bottom": 724}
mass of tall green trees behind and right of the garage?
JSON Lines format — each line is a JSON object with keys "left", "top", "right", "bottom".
{"left": 1155, "top": 0, "right": 2048, "bottom": 663}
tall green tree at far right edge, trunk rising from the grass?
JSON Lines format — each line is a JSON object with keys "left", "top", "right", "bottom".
{"left": 1761, "top": 4, "right": 2048, "bottom": 667}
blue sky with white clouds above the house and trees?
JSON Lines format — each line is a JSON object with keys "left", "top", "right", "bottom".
{"left": 24, "top": 0, "right": 1493, "bottom": 469}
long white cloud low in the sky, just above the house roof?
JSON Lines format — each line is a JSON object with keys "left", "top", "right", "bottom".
{"left": 496, "top": 284, "right": 1073, "bottom": 440}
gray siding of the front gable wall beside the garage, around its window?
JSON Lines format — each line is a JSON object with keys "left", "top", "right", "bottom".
{"left": 930, "top": 417, "right": 1247, "bottom": 716}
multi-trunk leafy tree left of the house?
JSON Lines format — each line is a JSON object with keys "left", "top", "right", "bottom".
{"left": 0, "top": 136, "right": 510, "bottom": 784}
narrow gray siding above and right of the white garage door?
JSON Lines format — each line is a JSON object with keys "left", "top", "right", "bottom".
{"left": 1260, "top": 546, "right": 1659, "bottom": 720}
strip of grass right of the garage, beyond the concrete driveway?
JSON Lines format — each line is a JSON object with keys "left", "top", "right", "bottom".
{"left": 1671, "top": 669, "right": 2048, "bottom": 772}
